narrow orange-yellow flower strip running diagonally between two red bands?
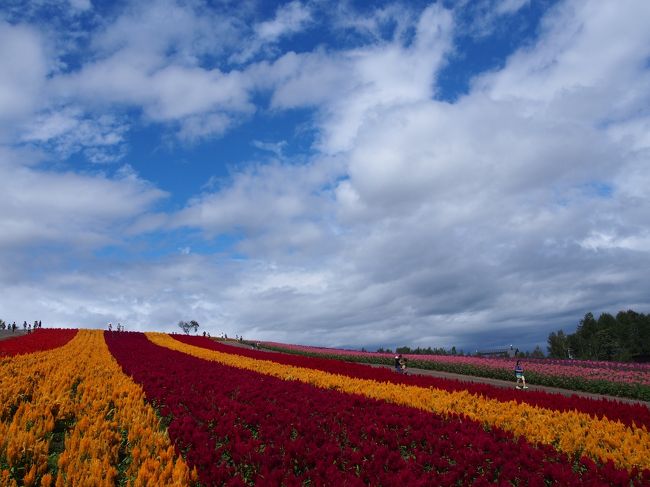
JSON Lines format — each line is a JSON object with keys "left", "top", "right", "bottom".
{"left": 147, "top": 333, "right": 650, "bottom": 469}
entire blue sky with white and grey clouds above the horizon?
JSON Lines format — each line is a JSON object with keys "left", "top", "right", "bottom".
{"left": 0, "top": 0, "right": 650, "bottom": 350}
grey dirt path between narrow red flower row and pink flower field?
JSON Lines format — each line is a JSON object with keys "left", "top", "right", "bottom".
{"left": 219, "top": 340, "right": 650, "bottom": 408}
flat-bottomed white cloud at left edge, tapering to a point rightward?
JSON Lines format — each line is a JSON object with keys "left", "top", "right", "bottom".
{"left": 0, "top": 153, "right": 165, "bottom": 252}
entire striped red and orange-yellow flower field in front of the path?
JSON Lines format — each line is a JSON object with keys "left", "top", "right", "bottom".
{"left": 0, "top": 330, "right": 650, "bottom": 486}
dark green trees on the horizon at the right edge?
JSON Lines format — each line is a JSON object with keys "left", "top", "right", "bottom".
{"left": 548, "top": 310, "right": 650, "bottom": 362}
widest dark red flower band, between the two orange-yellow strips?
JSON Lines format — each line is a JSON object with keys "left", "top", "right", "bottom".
{"left": 105, "top": 333, "right": 650, "bottom": 485}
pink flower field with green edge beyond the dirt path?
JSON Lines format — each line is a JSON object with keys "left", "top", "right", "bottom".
{"left": 262, "top": 342, "right": 650, "bottom": 401}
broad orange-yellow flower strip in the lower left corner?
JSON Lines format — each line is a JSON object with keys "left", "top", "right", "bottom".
{"left": 0, "top": 330, "right": 191, "bottom": 486}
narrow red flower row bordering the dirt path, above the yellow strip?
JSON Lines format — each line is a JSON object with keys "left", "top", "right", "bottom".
{"left": 172, "top": 335, "right": 650, "bottom": 428}
